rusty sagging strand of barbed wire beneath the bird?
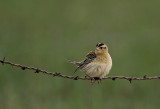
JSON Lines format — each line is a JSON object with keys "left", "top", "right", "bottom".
{"left": 0, "top": 57, "right": 160, "bottom": 83}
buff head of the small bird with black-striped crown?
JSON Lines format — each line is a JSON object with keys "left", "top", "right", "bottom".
{"left": 95, "top": 43, "right": 108, "bottom": 55}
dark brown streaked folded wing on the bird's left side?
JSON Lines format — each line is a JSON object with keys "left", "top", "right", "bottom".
{"left": 74, "top": 51, "right": 96, "bottom": 73}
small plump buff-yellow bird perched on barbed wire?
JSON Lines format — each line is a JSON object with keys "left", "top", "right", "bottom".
{"left": 69, "top": 43, "right": 112, "bottom": 82}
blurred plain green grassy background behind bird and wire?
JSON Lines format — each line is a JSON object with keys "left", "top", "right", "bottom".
{"left": 0, "top": 0, "right": 160, "bottom": 109}
